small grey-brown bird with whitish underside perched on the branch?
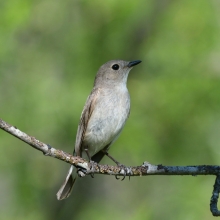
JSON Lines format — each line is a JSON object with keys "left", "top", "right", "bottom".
{"left": 57, "top": 60, "right": 141, "bottom": 200}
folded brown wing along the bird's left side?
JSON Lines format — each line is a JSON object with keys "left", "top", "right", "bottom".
{"left": 74, "top": 88, "right": 100, "bottom": 156}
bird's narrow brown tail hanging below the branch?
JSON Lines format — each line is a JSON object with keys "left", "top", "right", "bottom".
{"left": 57, "top": 166, "right": 77, "bottom": 200}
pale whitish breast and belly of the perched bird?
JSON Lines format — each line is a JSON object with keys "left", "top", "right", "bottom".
{"left": 83, "top": 87, "right": 130, "bottom": 156}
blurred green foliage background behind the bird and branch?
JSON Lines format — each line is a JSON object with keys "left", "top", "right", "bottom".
{"left": 0, "top": 0, "right": 220, "bottom": 220}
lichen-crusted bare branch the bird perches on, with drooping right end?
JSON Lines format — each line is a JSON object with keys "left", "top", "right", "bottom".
{"left": 0, "top": 119, "right": 220, "bottom": 216}
